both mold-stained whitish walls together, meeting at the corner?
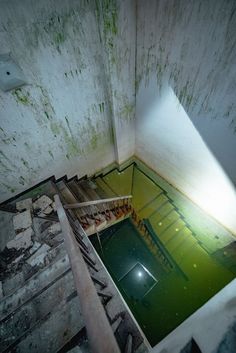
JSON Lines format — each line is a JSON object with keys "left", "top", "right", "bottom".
{"left": 0, "top": 0, "right": 236, "bottom": 231}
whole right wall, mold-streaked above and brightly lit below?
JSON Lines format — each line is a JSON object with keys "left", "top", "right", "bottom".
{"left": 136, "top": 0, "right": 236, "bottom": 233}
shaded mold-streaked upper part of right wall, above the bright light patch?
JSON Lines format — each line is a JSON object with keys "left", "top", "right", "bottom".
{"left": 136, "top": 0, "right": 236, "bottom": 184}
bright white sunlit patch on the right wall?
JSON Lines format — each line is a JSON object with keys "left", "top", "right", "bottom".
{"left": 137, "top": 85, "right": 236, "bottom": 233}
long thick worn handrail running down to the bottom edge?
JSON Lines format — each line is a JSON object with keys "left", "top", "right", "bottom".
{"left": 54, "top": 195, "right": 120, "bottom": 353}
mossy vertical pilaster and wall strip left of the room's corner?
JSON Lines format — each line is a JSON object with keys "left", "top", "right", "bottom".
{"left": 96, "top": 0, "right": 136, "bottom": 163}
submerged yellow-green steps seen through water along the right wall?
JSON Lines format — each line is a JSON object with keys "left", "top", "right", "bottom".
{"left": 94, "top": 167, "right": 205, "bottom": 267}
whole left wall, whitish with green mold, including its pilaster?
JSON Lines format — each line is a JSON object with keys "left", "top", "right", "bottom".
{"left": 0, "top": 0, "right": 135, "bottom": 201}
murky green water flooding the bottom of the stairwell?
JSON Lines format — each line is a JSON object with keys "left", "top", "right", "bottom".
{"left": 91, "top": 165, "right": 235, "bottom": 346}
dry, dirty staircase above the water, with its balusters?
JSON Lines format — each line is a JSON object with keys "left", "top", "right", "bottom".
{"left": 0, "top": 178, "right": 147, "bottom": 353}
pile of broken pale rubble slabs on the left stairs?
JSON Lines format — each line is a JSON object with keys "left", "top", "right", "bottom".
{"left": 0, "top": 195, "right": 63, "bottom": 300}
